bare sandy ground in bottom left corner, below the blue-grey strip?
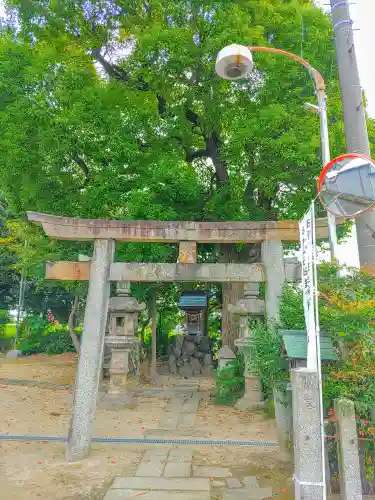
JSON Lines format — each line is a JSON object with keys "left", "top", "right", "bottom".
{"left": 0, "top": 442, "right": 142, "bottom": 500}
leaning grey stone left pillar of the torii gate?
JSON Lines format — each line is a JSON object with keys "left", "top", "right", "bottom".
{"left": 67, "top": 240, "right": 114, "bottom": 462}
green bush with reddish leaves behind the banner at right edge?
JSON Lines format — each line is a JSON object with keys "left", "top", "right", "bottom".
{"left": 281, "top": 264, "right": 375, "bottom": 419}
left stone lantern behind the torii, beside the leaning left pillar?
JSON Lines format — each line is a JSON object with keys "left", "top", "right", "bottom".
{"left": 104, "top": 282, "right": 146, "bottom": 408}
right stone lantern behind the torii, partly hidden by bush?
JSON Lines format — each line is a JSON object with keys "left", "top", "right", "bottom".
{"left": 229, "top": 283, "right": 264, "bottom": 410}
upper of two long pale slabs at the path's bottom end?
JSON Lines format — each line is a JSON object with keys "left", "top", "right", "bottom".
{"left": 111, "top": 477, "right": 210, "bottom": 491}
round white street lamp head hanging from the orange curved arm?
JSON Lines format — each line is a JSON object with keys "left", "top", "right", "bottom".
{"left": 216, "top": 43, "right": 253, "bottom": 80}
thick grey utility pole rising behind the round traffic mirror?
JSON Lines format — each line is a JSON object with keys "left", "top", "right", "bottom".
{"left": 330, "top": 0, "right": 375, "bottom": 267}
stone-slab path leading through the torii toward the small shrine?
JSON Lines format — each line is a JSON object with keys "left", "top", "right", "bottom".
{"left": 104, "top": 379, "right": 272, "bottom": 500}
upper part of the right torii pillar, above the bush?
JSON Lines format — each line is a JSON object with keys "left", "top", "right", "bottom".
{"left": 262, "top": 240, "right": 285, "bottom": 322}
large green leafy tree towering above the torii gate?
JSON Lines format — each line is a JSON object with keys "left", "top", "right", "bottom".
{"left": 0, "top": 0, "right": 358, "bottom": 343}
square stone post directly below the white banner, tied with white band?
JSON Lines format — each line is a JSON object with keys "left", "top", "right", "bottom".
{"left": 291, "top": 368, "right": 326, "bottom": 500}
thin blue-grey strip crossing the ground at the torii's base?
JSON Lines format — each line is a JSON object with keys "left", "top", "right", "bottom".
{"left": 0, "top": 434, "right": 278, "bottom": 448}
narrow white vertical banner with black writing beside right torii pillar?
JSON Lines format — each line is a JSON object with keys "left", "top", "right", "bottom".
{"left": 299, "top": 204, "right": 317, "bottom": 370}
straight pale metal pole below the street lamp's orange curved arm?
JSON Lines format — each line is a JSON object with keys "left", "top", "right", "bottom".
{"left": 317, "top": 88, "right": 338, "bottom": 262}
